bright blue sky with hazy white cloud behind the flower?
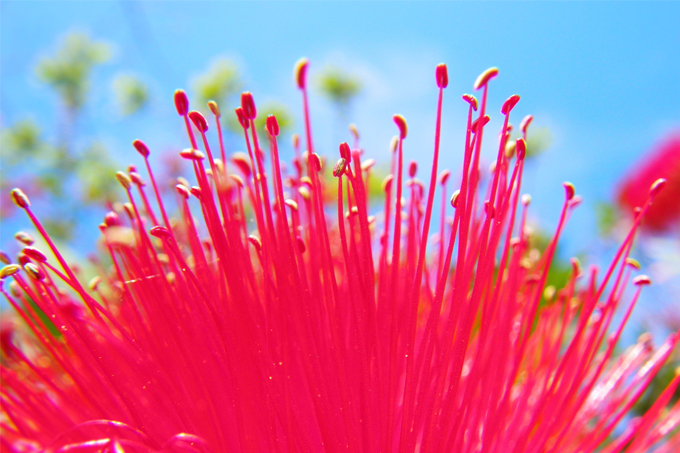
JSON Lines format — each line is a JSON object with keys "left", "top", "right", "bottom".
{"left": 0, "top": 1, "right": 680, "bottom": 322}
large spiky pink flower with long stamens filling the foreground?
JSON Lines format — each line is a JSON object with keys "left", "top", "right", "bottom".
{"left": 0, "top": 60, "right": 680, "bottom": 453}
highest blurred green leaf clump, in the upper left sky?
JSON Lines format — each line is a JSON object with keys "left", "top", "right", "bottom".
{"left": 36, "top": 33, "right": 111, "bottom": 111}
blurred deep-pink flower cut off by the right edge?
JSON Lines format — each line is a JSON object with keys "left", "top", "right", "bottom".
{"left": 617, "top": 131, "right": 680, "bottom": 231}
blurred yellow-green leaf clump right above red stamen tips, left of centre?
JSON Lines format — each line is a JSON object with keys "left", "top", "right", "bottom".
{"left": 193, "top": 58, "right": 243, "bottom": 110}
